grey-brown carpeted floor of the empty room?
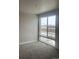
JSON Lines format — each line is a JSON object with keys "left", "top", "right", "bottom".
{"left": 19, "top": 42, "right": 58, "bottom": 59}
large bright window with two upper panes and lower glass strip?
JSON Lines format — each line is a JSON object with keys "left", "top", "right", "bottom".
{"left": 39, "top": 15, "right": 56, "bottom": 46}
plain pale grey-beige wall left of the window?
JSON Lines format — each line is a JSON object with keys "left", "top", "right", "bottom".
{"left": 19, "top": 12, "right": 38, "bottom": 43}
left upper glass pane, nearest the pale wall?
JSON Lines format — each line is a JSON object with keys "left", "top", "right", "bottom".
{"left": 40, "top": 17, "right": 47, "bottom": 36}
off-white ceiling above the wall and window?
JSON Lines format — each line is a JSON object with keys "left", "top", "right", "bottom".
{"left": 19, "top": 0, "right": 59, "bottom": 14}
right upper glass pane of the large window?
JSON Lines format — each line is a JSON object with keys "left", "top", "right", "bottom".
{"left": 48, "top": 15, "right": 56, "bottom": 39}
